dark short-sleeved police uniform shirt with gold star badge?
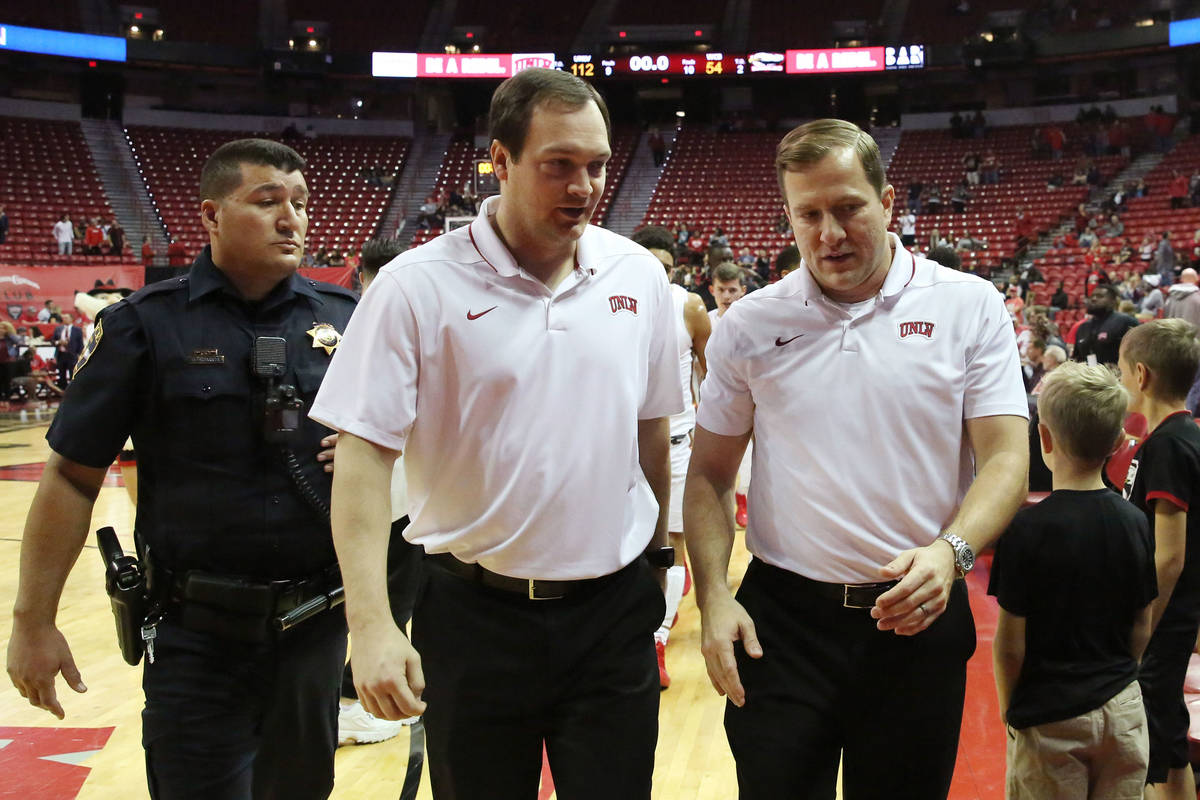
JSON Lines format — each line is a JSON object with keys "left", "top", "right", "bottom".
{"left": 47, "top": 248, "right": 355, "bottom": 579}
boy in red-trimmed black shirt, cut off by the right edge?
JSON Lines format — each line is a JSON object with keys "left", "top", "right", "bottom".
{"left": 1118, "top": 319, "right": 1200, "bottom": 800}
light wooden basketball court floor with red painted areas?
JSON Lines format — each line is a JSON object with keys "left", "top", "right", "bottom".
{"left": 0, "top": 408, "right": 1004, "bottom": 800}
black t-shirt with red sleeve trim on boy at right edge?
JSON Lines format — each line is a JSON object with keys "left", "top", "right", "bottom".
{"left": 1123, "top": 411, "right": 1200, "bottom": 628}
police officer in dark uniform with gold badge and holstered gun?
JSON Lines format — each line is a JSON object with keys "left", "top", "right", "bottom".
{"left": 8, "top": 139, "right": 355, "bottom": 800}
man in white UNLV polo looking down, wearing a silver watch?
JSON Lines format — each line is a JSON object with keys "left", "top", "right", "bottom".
{"left": 684, "top": 120, "right": 1028, "bottom": 800}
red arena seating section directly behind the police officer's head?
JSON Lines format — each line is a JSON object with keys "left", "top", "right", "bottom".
{"left": 126, "top": 127, "right": 409, "bottom": 261}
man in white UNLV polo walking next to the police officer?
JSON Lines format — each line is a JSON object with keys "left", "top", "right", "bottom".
{"left": 311, "top": 70, "right": 683, "bottom": 800}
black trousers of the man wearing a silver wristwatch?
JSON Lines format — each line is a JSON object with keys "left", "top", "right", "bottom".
{"left": 725, "top": 559, "right": 976, "bottom": 800}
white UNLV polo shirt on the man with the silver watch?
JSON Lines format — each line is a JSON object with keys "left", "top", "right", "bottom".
{"left": 697, "top": 234, "right": 1028, "bottom": 583}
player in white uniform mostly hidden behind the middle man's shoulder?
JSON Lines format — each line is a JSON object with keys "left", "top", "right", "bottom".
{"left": 631, "top": 225, "right": 712, "bottom": 688}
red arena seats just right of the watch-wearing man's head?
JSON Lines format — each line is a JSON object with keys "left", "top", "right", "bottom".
{"left": 888, "top": 125, "right": 1127, "bottom": 277}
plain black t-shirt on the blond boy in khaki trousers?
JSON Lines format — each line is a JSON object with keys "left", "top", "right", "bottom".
{"left": 988, "top": 489, "right": 1158, "bottom": 728}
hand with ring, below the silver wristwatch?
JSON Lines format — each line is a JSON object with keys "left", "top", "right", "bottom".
{"left": 871, "top": 539, "right": 958, "bottom": 636}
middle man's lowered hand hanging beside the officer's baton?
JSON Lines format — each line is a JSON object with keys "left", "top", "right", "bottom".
{"left": 350, "top": 625, "right": 425, "bottom": 720}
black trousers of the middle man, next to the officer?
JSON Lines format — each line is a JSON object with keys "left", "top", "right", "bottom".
{"left": 413, "top": 559, "right": 666, "bottom": 800}
